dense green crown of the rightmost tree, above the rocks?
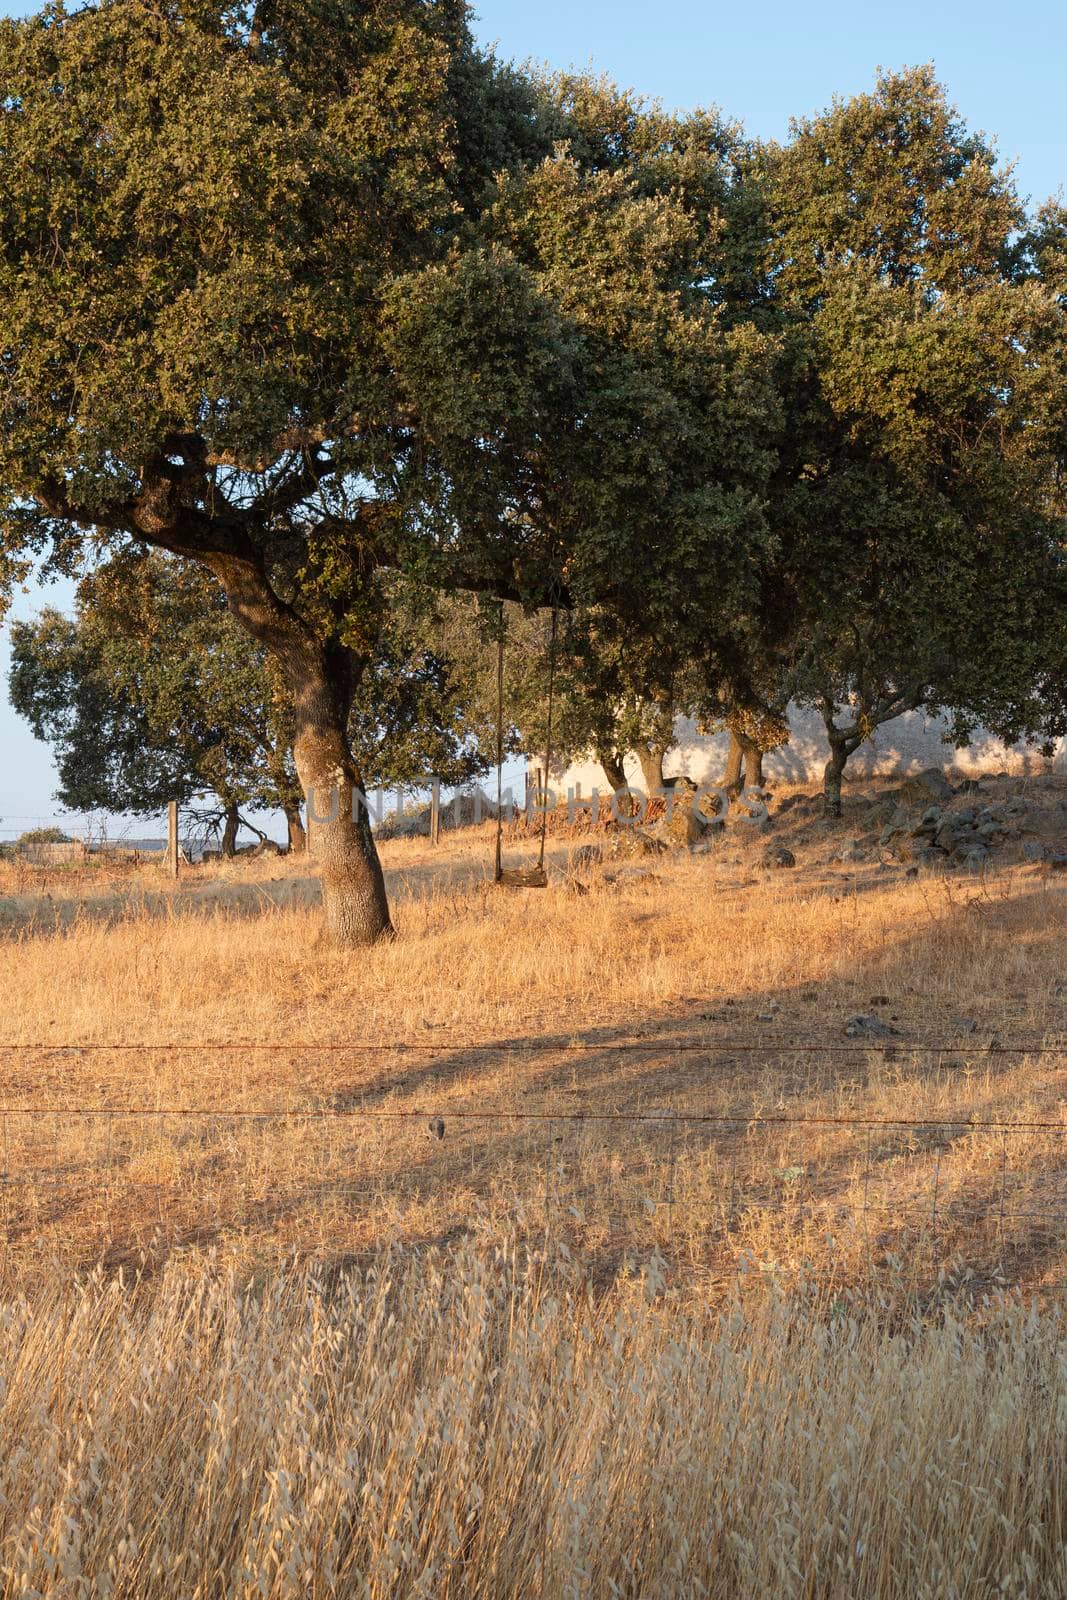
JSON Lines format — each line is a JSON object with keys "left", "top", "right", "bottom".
{"left": 755, "top": 69, "right": 1065, "bottom": 784}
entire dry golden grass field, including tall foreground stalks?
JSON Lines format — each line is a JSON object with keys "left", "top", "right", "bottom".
{"left": 0, "top": 771, "right": 1067, "bottom": 1600}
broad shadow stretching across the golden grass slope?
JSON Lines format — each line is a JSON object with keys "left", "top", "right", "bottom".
{"left": 5, "top": 885, "right": 1067, "bottom": 1285}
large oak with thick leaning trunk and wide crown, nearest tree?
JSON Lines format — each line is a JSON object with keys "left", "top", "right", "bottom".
{"left": 0, "top": 0, "right": 773, "bottom": 944}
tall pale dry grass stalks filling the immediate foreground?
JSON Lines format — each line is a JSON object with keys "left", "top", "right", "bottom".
{"left": 0, "top": 1246, "right": 1067, "bottom": 1600}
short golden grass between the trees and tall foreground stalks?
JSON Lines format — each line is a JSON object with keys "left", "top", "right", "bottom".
{"left": 0, "top": 793, "right": 1067, "bottom": 1286}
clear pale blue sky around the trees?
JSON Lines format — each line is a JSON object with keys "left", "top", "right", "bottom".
{"left": 0, "top": 0, "right": 1067, "bottom": 837}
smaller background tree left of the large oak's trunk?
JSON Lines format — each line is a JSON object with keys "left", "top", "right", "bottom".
{"left": 10, "top": 552, "right": 304, "bottom": 854}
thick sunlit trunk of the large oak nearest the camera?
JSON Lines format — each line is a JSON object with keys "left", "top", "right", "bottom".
{"left": 293, "top": 666, "right": 394, "bottom": 949}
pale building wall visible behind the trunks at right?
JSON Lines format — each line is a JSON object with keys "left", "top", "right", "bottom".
{"left": 563, "top": 706, "right": 1067, "bottom": 795}
